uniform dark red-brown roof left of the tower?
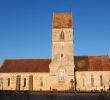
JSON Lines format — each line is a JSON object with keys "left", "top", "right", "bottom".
{"left": 0, "top": 59, "right": 51, "bottom": 72}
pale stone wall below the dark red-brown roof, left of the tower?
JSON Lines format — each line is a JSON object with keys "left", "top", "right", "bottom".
{"left": 0, "top": 73, "right": 50, "bottom": 91}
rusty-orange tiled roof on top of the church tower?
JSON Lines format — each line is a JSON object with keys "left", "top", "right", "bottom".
{"left": 53, "top": 13, "right": 72, "bottom": 28}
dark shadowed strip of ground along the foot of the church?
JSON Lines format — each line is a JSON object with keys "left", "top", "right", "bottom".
{"left": 0, "top": 91, "right": 110, "bottom": 100}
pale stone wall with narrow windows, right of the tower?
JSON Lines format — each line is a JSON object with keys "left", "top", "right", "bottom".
{"left": 76, "top": 71, "right": 110, "bottom": 91}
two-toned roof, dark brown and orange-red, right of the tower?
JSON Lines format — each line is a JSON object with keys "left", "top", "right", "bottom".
{"left": 75, "top": 55, "right": 110, "bottom": 71}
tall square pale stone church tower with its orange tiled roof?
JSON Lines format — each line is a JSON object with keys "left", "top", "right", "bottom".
{"left": 49, "top": 13, "right": 74, "bottom": 90}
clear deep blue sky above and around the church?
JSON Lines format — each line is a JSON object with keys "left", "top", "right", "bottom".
{"left": 0, "top": 0, "right": 110, "bottom": 64}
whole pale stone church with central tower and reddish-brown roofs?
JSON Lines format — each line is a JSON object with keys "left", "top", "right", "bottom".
{"left": 0, "top": 12, "right": 110, "bottom": 91}
